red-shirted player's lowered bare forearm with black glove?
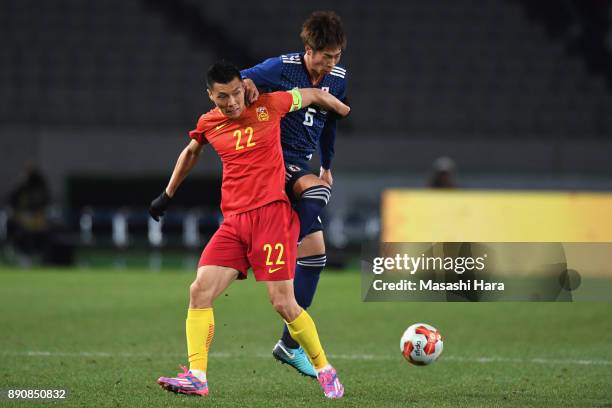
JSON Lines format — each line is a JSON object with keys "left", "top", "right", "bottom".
{"left": 149, "top": 140, "right": 204, "bottom": 221}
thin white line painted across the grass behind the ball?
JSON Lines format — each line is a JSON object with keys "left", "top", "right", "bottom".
{"left": 0, "top": 351, "right": 612, "bottom": 366}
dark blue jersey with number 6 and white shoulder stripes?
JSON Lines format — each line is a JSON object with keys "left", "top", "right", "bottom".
{"left": 241, "top": 53, "right": 346, "bottom": 169}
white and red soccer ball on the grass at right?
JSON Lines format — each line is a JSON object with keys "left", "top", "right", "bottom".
{"left": 400, "top": 323, "right": 444, "bottom": 365}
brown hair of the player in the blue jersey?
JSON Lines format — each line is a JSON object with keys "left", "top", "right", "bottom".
{"left": 300, "top": 11, "right": 346, "bottom": 51}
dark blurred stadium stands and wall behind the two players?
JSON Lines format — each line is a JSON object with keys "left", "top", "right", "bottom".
{"left": 0, "top": 0, "right": 612, "bottom": 269}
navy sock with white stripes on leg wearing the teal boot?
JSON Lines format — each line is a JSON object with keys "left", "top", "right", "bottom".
{"left": 282, "top": 254, "right": 327, "bottom": 348}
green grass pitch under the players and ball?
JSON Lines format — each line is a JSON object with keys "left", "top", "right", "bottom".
{"left": 0, "top": 269, "right": 612, "bottom": 408}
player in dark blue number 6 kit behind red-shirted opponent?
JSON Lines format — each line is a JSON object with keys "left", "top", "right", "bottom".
{"left": 241, "top": 11, "right": 346, "bottom": 378}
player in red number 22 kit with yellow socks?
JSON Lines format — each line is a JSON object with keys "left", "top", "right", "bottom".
{"left": 149, "top": 62, "right": 350, "bottom": 398}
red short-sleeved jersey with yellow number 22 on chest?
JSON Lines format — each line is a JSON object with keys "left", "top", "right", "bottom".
{"left": 189, "top": 92, "right": 301, "bottom": 217}
